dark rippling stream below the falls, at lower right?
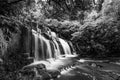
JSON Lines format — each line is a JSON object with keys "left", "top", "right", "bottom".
{"left": 52, "top": 59, "right": 120, "bottom": 80}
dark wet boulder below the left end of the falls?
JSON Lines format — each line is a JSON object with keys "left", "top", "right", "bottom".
{"left": 19, "top": 64, "right": 51, "bottom": 80}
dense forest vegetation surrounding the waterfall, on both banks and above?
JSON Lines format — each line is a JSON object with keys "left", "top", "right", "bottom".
{"left": 0, "top": 0, "right": 120, "bottom": 79}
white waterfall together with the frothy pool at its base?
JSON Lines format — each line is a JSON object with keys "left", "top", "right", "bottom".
{"left": 21, "top": 29, "right": 79, "bottom": 80}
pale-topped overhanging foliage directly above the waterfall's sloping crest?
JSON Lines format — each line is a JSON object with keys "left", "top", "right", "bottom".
{"left": 44, "top": 19, "right": 81, "bottom": 40}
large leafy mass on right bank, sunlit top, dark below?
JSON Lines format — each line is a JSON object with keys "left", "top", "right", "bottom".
{"left": 73, "top": 0, "right": 120, "bottom": 57}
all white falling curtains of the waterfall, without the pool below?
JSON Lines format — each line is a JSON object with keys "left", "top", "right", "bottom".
{"left": 32, "top": 30, "right": 76, "bottom": 61}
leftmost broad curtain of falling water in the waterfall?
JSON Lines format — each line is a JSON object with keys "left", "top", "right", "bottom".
{"left": 33, "top": 30, "right": 52, "bottom": 61}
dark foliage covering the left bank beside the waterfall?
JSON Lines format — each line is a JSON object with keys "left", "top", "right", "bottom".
{"left": 0, "top": 16, "right": 31, "bottom": 80}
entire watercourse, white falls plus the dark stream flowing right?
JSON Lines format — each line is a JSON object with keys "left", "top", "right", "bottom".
{"left": 22, "top": 30, "right": 120, "bottom": 80}
